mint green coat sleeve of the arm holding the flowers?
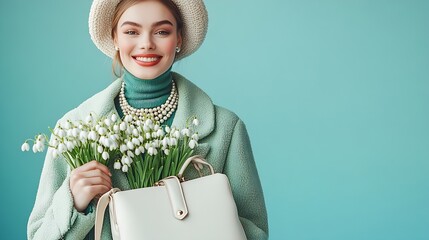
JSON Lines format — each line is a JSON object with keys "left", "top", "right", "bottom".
{"left": 27, "top": 133, "right": 95, "bottom": 240}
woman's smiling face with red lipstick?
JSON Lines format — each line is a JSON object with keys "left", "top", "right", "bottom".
{"left": 114, "top": 0, "right": 181, "bottom": 79}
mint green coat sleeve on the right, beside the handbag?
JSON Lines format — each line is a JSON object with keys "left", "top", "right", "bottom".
{"left": 224, "top": 120, "right": 268, "bottom": 240}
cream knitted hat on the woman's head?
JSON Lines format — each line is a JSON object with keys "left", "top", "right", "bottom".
{"left": 88, "top": 0, "right": 208, "bottom": 60}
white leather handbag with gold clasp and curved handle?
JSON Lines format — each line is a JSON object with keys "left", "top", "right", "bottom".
{"left": 95, "top": 156, "right": 246, "bottom": 240}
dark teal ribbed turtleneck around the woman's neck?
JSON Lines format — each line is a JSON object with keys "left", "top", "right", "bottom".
{"left": 115, "top": 67, "right": 176, "bottom": 126}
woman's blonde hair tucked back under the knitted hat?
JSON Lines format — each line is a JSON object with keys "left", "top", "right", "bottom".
{"left": 111, "top": 0, "right": 183, "bottom": 77}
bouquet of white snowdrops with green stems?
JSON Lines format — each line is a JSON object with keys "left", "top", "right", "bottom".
{"left": 21, "top": 114, "right": 199, "bottom": 189}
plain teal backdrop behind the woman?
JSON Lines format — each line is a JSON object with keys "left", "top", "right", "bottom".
{"left": 0, "top": 0, "right": 429, "bottom": 240}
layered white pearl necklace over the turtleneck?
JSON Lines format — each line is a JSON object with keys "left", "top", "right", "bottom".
{"left": 119, "top": 80, "right": 179, "bottom": 123}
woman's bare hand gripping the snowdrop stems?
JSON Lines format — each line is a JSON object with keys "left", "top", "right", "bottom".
{"left": 70, "top": 160, "right": 112, "bottom": 212}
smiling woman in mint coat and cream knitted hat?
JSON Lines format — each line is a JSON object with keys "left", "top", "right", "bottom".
{"left": 28, "top": 0, "right": 268, "bottom": 239}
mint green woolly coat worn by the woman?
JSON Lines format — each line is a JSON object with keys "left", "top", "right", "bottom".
{"left": 27, "top": 73, "right": 268, "bottom": 240}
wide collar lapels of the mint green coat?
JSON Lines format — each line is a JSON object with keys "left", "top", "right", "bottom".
{"left": 72, "top": 72, "right": 215, "bottom": 156}
